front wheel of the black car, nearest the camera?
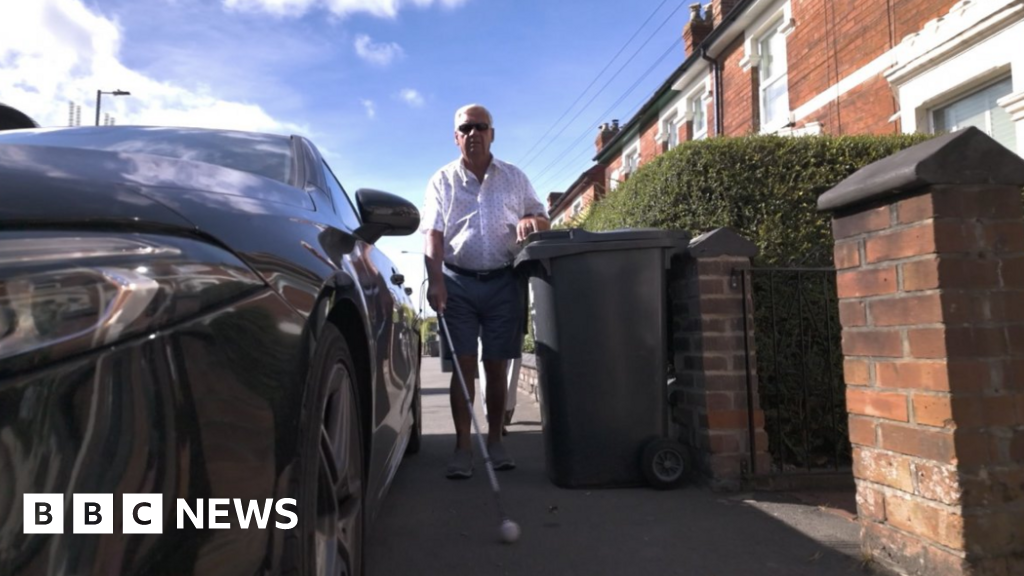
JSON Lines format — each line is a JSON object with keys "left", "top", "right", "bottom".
{"left": 298, "top": 324, "right": 366, "bottom": 576}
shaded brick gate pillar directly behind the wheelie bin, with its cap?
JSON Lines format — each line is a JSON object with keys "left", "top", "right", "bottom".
{"left": 671, "top": 229, "right": 769, "bottom": 490}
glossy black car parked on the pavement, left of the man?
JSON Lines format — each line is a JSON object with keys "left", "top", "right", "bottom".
{"left": 0, "top": 126, "right": 421, "bottom": 576}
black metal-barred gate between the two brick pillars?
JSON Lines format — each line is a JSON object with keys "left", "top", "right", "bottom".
{"left": 742, "top": 268, "right": 851, "bottom": 475}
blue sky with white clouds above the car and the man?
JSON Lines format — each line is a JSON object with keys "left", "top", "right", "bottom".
{"left": 0, "top": 0, "right": 695, "bottom": 309}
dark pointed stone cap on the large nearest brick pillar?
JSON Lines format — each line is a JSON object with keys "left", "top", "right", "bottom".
{"left": 818, "top": 126, "right": 1024, "bottom": 211}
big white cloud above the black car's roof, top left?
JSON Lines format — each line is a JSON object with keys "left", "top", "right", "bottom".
{"left": 0, "top": 0, "right": 306, "bottom": 132}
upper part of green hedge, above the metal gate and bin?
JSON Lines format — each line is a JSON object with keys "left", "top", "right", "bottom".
{"left": 581, "top": 134, "right": 931, "bottom": 265}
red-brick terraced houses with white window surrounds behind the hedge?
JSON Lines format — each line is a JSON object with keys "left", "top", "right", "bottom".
{"left": 551, "top": 0, "right": 1024, "bottom": 223}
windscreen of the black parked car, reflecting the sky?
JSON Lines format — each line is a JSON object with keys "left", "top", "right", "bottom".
{"left": 0, "top": 126, "right": 293, "bottom": 183}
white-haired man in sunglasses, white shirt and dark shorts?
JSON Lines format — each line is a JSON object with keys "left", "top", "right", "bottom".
{"left": 422, "top": 105, "right": 551, "bottom": 479}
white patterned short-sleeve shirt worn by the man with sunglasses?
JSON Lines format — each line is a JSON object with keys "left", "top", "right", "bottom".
{"left": 420, "top": 158, "right": 547, "bottom": 271}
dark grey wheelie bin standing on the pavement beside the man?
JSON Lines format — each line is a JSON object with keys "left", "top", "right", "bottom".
{"left": 516, "top": 230, "right": 690, "bottom": 488}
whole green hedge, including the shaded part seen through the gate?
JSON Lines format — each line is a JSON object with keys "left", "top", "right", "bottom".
{"left": 582, "top": 134, "right": 928, "bottom": 474}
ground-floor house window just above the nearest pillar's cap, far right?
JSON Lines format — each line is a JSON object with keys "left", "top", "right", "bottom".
{"left": 932, "top": 78, "right": 1017, "bottom": 152}
